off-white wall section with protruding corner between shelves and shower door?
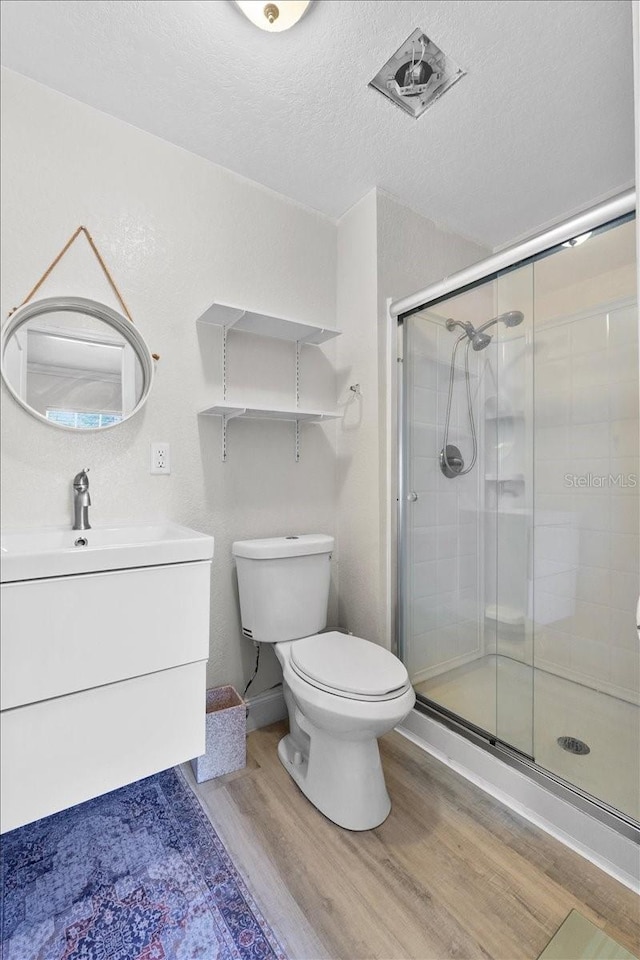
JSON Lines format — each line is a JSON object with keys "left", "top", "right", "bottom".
{"left": 337, "top": 190, "right": 489, "bottom": 646}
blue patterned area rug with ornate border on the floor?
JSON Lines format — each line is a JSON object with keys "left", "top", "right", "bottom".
{"left": 0, "top": 768, "right": 286, "bottom": 960}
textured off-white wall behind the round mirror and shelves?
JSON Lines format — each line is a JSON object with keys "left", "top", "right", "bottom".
{"left": 2, "top": 71, "right": 338, "bottom": 692}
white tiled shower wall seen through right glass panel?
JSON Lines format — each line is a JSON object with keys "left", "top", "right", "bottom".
{"left": 534, "top": 302, "right": 640, "bottom": 702}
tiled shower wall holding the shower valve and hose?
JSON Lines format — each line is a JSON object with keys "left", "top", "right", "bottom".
{"left": 405, "top": 318, "right": 484, "bottom": 683}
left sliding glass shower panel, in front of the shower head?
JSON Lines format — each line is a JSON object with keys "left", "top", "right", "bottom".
{"left": 401, "top": 274, "right": 533, "bottom": 755}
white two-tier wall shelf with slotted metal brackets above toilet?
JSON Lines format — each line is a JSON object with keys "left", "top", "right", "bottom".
{"left": 196, "top": 302, "right": 341, "bottom": 463}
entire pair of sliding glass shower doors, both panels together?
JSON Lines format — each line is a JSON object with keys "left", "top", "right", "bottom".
{"left": 399, "top": 216, "right": 640, "bottom": 821}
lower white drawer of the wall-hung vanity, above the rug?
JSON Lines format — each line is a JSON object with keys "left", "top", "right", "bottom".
{"left": 0, "top": 661, "right": 206, "bottom": 832}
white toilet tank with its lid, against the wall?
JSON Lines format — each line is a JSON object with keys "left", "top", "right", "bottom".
{"left": 231, "top": 534, "right": 334, "bottom": 643}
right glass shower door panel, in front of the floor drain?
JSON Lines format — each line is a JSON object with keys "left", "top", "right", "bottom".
{"left": 533, "top": 218, "right": 640, "bottom": 821}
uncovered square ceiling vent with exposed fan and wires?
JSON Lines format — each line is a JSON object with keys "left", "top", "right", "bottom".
{"left": 369, "top": 29, "right": 465, "bottom": 118}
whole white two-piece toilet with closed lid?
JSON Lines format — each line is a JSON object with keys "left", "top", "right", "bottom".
{"left": 232, "top": 534, "right": 415, "bottom": 830}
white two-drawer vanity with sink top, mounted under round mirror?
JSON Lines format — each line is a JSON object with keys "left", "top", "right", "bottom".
{"left": 0, "top": 524, "right": 213, "bottom": 832}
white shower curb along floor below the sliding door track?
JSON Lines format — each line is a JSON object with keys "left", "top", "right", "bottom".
{"left": 396, "top": 709, "right": 640, "bottom": 893}
